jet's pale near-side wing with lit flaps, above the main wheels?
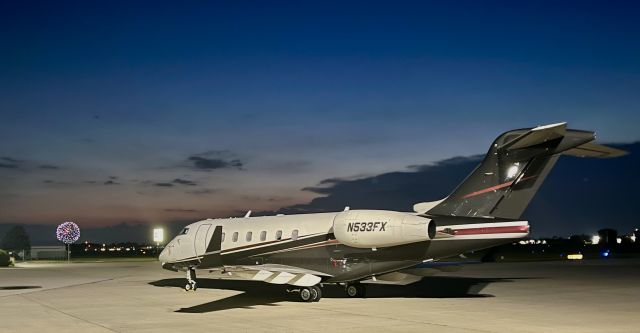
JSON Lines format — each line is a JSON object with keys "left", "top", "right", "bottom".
{"left": 205, "top": 264, "right": 330, "bottom": 287}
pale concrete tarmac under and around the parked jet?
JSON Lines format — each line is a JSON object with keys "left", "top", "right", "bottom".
{"left": 0, "top": 259, "right": 640, "bottom": 333}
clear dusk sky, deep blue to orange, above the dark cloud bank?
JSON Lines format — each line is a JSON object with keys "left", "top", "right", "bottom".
{"left": 0, "top": 1, "right": 640, "bottom": 232}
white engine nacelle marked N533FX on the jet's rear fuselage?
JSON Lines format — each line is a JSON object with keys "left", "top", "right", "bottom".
{"left": 333, "top": 210, "right": 436, "bottom": 248}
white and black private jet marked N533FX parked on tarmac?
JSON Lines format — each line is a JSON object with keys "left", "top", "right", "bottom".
{"left": 159, "top": 123, "right": 625, "bottom": 302}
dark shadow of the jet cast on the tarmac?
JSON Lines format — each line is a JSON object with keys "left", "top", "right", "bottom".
{"left": 149, "top": 276, "right": 522, "bottom": 313}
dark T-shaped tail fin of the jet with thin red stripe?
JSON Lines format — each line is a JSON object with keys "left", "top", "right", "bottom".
{"left": 426, "top": 123, "right": 625, "bottom": 219}
